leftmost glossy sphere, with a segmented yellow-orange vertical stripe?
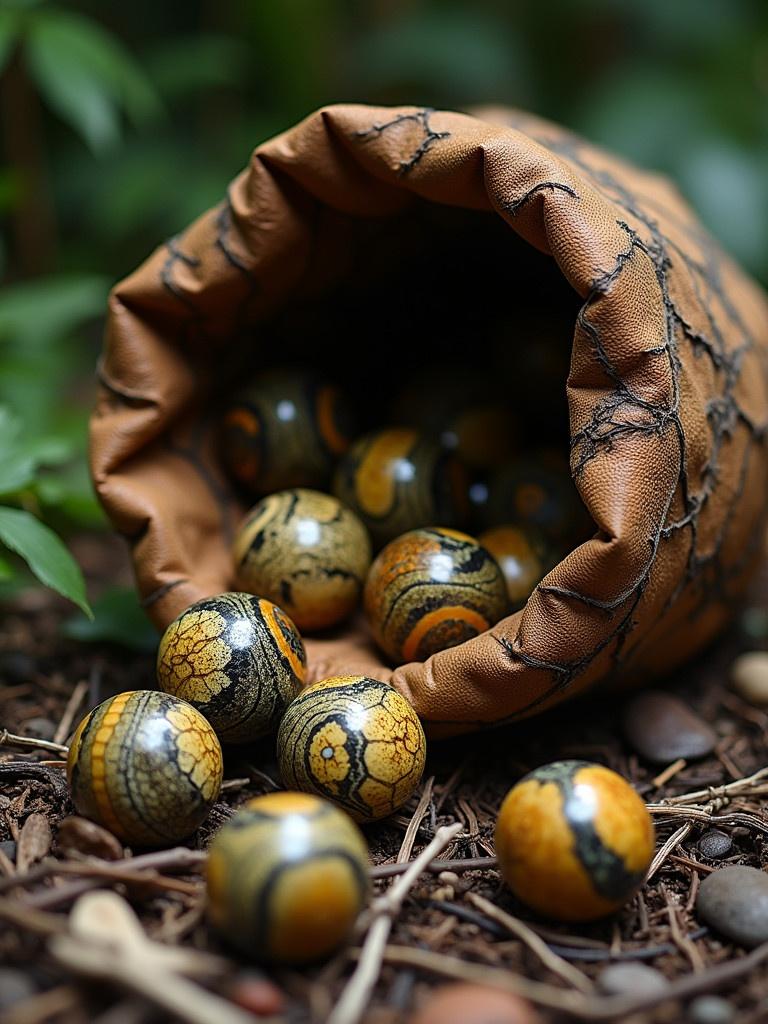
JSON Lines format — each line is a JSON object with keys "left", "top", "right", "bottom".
{"left": 67, "top": 690, "right": 223, "bottom": 846}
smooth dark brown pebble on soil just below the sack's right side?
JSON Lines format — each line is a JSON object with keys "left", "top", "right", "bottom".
{"left": 624, "top": 690, "right": 717, "bottom": 764}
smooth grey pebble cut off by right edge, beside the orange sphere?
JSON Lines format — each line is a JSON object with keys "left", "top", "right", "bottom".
{"left": 696, "top": 865, "right": 768, "bottom": 948}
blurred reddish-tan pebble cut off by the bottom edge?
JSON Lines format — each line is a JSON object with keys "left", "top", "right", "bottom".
{"left": 411, "top": 982, "right": 542, "bottom": 1024}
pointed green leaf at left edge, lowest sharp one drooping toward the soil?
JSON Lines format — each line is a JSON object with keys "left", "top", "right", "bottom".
{"left": 0, "top": 507, "right": 92, "bottom": 615}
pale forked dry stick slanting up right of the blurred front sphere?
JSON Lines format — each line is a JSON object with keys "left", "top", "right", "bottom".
{"left": 327, "top": 822, "right": 462, "bottom": 1024}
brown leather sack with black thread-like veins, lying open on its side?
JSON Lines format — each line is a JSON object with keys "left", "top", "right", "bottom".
{"left": 92, "top": 105, "right": 768, "bottom": 735}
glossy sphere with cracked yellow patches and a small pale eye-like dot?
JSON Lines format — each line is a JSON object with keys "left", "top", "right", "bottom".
{"left": 278, "top": 676, "right": 426, "bottom": 821}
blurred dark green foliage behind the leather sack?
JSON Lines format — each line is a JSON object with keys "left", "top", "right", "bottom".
{"left": 0, "top": 0, "right": 768, "bottom": 606}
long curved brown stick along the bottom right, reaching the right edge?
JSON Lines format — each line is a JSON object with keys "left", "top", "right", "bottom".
{"left": 384, "top": 942, "right": 768, "bottom": 1021}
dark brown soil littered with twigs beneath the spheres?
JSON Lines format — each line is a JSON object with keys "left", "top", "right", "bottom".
{"left": 0, "top": 539, "right": 768, "bottom": 1024}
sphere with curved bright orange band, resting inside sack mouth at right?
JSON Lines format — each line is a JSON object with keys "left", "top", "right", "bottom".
{"left": 364, "top": 527, "right": 509, "bottom": 664}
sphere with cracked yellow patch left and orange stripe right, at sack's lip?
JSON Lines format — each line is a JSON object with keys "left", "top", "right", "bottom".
{"left": 157, "top": 593, "right": 306, "bottom": 743}
